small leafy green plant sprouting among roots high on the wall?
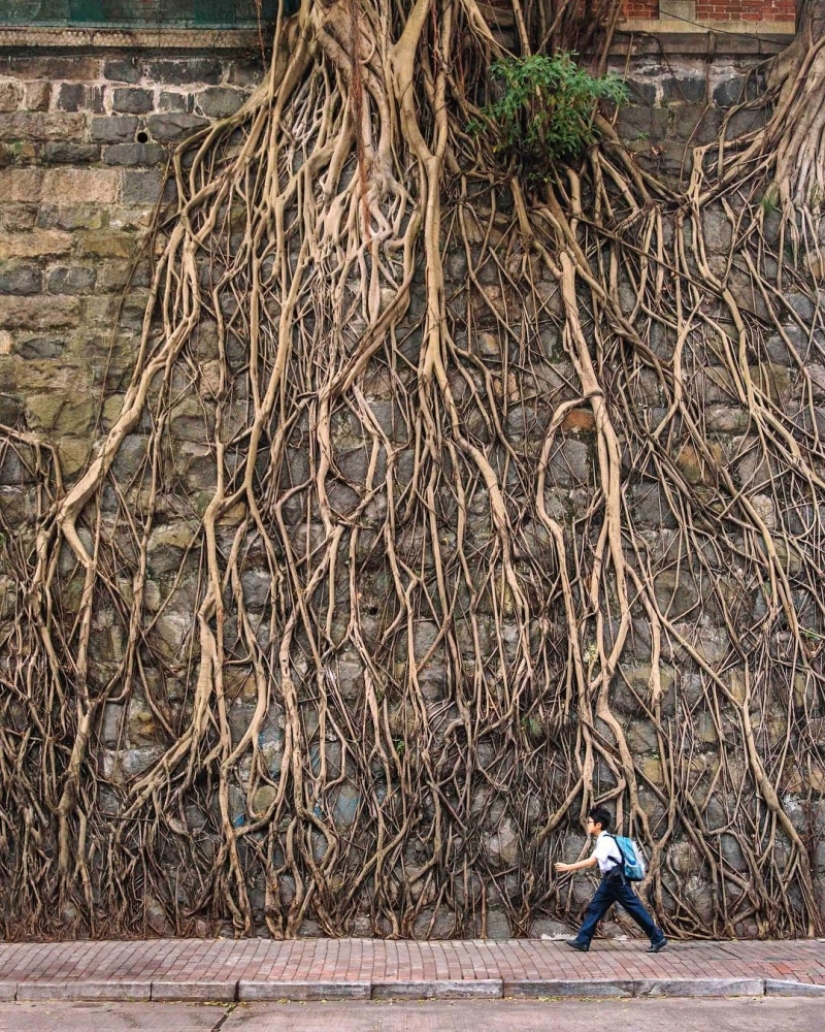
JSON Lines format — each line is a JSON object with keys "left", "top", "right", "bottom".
{"left": 468, "top": 53, "right": 628, "bottom": 183}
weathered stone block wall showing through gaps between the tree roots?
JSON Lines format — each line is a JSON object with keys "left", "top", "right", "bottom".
{"left": 0, "top": 28, "right": 825, "bottom": 937}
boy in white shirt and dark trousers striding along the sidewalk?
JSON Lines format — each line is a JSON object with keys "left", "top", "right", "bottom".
{"left": 556, "top": 806, "right": 667, "bottom": 954}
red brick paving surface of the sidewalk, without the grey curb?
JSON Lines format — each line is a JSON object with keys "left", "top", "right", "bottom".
{"left": 0, "top": 939, "right": 825, "bottom": 998}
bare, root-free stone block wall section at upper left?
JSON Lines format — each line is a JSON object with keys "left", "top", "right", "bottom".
{"left": 0, "top": 51, "right": 263, "bottom": 476}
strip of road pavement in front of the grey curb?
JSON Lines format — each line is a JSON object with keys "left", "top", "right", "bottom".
{"left": 0, "top": 998, "right": 825, "bottom": 1032}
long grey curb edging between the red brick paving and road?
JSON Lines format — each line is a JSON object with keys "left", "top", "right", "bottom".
{"left": 6, "top": 978, "right": 825, "bottom": 1003}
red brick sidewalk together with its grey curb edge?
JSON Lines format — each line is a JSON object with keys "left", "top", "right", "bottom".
{"left": 0, "top": 939, "right": 825, "bottom": 1001}
